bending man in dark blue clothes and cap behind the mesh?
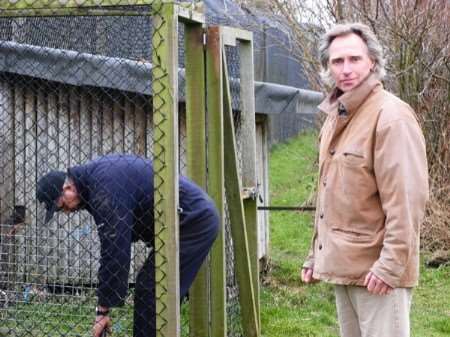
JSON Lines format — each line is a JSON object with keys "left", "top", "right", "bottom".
{"left": 37, "top": 155, "right": 219, "bottom": 337}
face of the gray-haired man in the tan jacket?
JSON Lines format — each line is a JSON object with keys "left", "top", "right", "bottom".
{"left": 328, "top": 34, "right": 374, "bottom": 92}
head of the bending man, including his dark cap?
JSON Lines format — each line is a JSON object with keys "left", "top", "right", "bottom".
{"left": 36, "top": 171, "right": 81, "bottom": 223}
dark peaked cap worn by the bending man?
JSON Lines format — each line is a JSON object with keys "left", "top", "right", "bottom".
{"left": 36, "top": 171, "right": 66, "bottom": 223}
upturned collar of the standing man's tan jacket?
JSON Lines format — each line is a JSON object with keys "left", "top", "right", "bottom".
{"left": 318, "top": 74, "right": 383, "bottom": 116}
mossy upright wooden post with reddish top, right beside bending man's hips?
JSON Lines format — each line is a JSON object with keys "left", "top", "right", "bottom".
{"left": 206, "top": 27, "right": 227, "bottom": 337}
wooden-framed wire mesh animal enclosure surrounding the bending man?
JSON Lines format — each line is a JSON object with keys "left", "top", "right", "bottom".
{"left": 0, "top": 1, "right": 264, "bottom": 337}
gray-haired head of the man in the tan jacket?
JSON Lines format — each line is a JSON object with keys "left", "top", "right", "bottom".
{"left": 319, "top": 23, "right": 385, "bottom": 92}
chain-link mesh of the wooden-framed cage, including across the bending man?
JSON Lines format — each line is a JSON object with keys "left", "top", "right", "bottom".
{"left": 0, "top": 1, "right": 256, "bottom": 336}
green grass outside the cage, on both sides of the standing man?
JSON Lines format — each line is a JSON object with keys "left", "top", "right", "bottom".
{"left": 261, "top": 132, "right": 450, "bottom": 337}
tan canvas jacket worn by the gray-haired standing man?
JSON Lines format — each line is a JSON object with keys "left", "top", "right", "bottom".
{"left": 304, "top": 76, "right": 428, "bottom": 287}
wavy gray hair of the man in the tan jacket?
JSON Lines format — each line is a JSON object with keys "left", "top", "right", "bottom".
{"left": 319, "top": 22, "right": 386, "bottom": 86}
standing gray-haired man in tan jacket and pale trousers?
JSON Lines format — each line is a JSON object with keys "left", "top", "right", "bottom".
{"left": 301, "top": 23, "right": 428, "bottom": 337}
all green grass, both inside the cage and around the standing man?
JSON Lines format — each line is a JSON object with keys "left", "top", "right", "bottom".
{"left": 0, "top": 129, "right": 450, "bottom": 337}
